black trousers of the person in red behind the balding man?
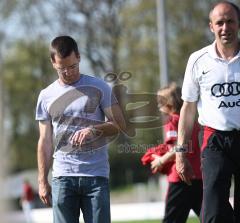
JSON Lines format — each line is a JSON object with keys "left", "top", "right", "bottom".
{"left": 163, "top": 180, "right": 202, "bottom": 223}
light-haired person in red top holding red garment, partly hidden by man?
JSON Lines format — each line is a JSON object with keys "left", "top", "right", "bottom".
{"left": 142, "top": 83, "right": 202, "bottom": 223}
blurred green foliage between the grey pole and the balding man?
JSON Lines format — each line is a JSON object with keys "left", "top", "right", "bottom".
{"left": 166, "top": 0, "right": 215, "bottom": 84}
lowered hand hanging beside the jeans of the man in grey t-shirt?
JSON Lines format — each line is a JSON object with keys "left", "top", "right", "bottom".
{"left": 38, "top": 181, "right": 52, "bottom": 207}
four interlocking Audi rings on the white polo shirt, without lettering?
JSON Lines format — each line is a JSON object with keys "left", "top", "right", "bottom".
{"left": 211, "top": 82, "right": 240, "bottom": 97}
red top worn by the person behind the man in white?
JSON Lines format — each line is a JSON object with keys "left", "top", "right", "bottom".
{"left": 164, "top": 114, "right": 202, "bottom": 183}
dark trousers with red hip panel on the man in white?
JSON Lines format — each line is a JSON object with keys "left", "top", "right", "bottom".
{"left": 201, "top": 127, "right": 240, "bottom": 223}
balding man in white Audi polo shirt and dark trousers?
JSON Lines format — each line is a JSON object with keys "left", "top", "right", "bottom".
{"left": 176, "top": 1, "right": 240, "bottom": 223}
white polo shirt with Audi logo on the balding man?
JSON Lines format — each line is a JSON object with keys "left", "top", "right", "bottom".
{"left": 182, "top": 42, "right": 240, "bottom": 131}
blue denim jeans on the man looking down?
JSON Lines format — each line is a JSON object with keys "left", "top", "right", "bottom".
{"left": 52, "top": 177, "right": 111, "bottom": 223}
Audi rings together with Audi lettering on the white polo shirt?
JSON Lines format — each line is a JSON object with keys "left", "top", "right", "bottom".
{"left": 211, "top": 81, "right": 240, "bottom": 109}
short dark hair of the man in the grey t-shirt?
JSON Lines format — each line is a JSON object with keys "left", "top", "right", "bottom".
{"left": 50, "top": 36, "right": 80, "bottom": 61}
